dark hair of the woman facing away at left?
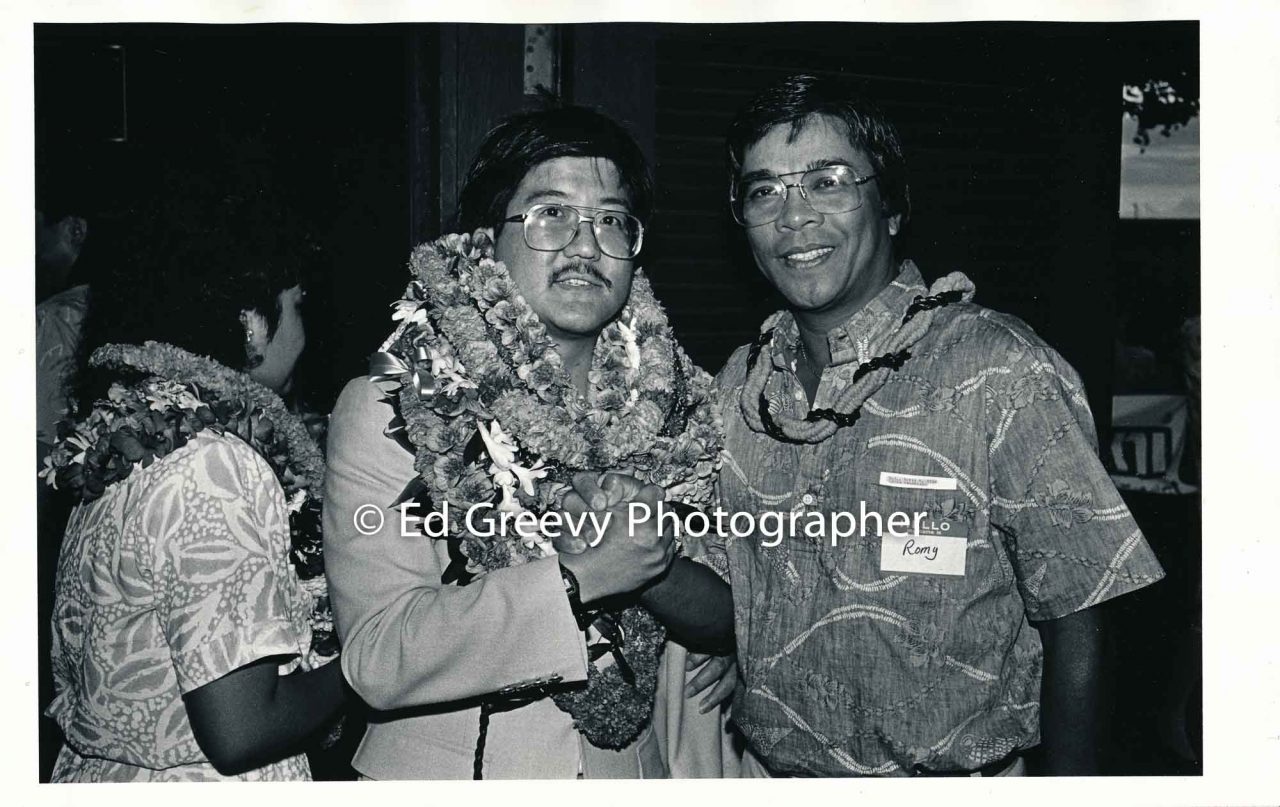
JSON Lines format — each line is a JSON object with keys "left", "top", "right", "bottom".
{"left": 82, "top": 152, "right": 315, "bottom": 394}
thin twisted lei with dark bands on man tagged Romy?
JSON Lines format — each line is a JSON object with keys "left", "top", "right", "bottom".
{"left": 739, "top": 272, "right": 974, "bottom": 443}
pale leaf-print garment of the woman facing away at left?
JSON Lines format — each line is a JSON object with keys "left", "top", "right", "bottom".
{"left": 47, "top": 432, "right": 311, "bottom": 781}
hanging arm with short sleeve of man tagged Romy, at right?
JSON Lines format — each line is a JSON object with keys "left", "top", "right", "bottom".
{"left": 987, "top": 338, "right": 1164, "bottom": 774}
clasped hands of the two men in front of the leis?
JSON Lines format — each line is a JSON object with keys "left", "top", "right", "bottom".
{"left": 554, "top": 473, "right": 676, "bottom": 602}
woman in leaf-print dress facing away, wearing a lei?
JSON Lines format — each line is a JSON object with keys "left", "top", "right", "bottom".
{"left": 41, "top": 161, "right": 346, "bottom": 781}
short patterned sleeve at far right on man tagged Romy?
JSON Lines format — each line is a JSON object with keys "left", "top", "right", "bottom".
{"left": 987, "top": 346, "right": 1164, "bottom": 620}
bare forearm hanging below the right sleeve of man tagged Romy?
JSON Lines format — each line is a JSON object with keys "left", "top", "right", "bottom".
{"left": 1036, "top": 608, "right": 1103, "bottom": 776}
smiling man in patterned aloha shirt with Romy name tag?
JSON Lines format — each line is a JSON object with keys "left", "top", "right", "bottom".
{"left": 704, "top": 76, "right": 1162, "bottom": 776}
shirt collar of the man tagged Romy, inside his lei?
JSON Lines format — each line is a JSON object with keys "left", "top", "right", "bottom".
{"left": 762, "top": 260, "right": 929, "bottom": 369}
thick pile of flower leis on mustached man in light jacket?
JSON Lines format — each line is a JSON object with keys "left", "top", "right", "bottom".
{"left": 371, "top": 231, "right": 722, "bottom": 748}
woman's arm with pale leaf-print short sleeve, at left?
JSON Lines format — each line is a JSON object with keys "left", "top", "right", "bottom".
{"left": 149, "top": 436, "right": 346, "bottom": 774}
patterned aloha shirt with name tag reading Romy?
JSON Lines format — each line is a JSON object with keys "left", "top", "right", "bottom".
{"left": 707, "top": 261, "right": 1164, "bottom": 776}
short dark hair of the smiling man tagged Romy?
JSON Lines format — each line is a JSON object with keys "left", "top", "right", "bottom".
{"left": 727, "top": 74, "right": 911, "bottom": 224}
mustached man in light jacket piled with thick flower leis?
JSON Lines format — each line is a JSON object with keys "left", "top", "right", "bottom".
{"left": 324, "top": 108, "right": 731, "bottom": 779}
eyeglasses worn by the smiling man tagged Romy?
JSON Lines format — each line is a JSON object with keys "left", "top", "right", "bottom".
{"left": 730, "top": 164, "right": 876, "bottom": 227}
